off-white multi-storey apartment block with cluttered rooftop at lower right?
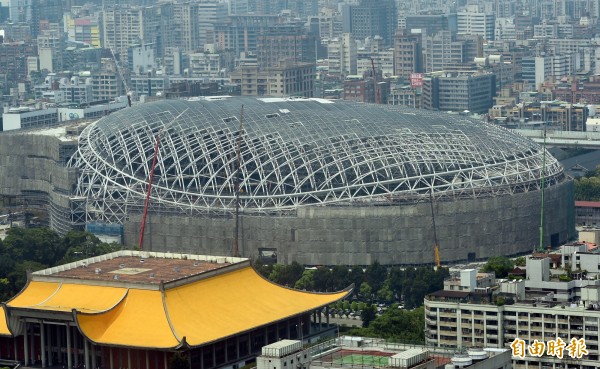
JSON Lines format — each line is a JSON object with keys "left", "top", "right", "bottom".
{"left": 425, "top": 244, "right": 600, "bottom": 369}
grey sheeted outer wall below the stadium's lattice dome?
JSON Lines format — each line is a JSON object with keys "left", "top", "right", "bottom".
{"left": 124, "top": 181, "right": 575, "bottom": 265}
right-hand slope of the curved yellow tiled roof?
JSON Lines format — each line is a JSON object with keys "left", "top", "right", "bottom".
{"left": 165, "top": 267, "right": 348, "bottom": 346}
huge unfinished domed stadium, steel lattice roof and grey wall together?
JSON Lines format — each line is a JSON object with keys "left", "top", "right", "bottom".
{"left": 0, "top": 97, "right": 574, "bottom": 265}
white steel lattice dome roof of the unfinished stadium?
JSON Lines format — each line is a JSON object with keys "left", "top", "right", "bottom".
{"left": 70, "top": 97, "right": 564, "bottom": 220}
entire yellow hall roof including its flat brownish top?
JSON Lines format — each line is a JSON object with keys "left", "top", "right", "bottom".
{"left": 0, "top": 251, "right": 349, "bottom": 349}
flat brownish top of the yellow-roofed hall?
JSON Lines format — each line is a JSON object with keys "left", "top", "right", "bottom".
{"left": 33, "top": 250, "right": 249, "bottom": 285}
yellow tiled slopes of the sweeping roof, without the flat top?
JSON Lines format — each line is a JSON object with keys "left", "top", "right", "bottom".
{"left": 0, "top": 266, "right": 349, "bottom": 348}
